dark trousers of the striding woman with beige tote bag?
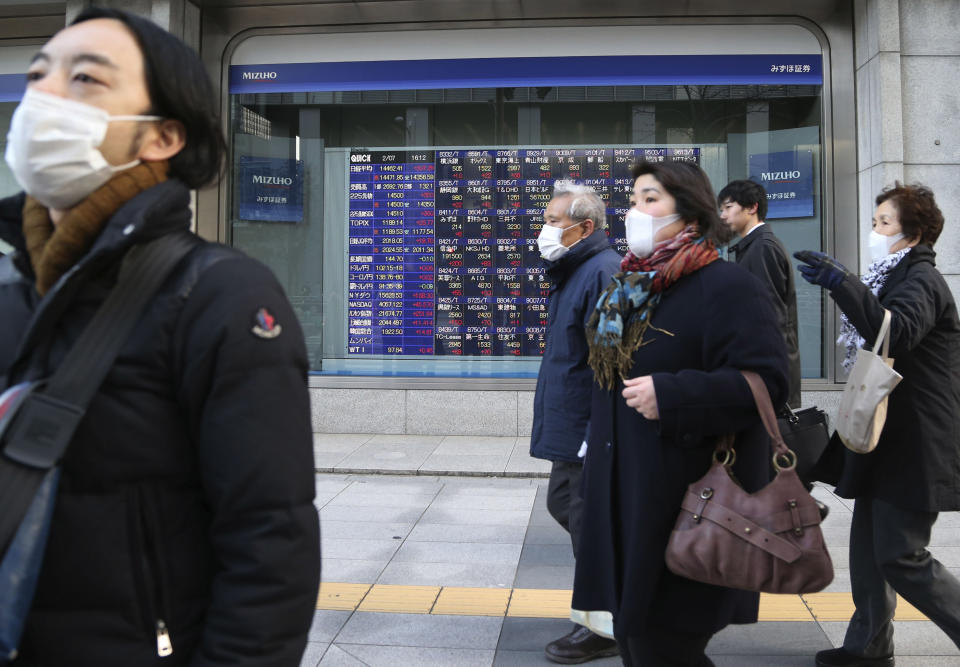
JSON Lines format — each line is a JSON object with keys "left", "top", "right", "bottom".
{"left": 843, "top": 498, "right": 960, "bottom": 658}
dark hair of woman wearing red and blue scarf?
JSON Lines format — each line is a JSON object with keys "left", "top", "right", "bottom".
{"left": 631, "top": 161, "right": 733, "bottom": 245}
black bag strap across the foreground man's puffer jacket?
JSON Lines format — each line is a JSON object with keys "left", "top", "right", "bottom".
{"left": 0, "top": 232, "right": 198, "bottom": 555}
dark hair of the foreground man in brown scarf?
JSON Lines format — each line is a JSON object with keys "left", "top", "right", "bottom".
{"left": 70, "top": 7, "right": 227, "bottom": 188}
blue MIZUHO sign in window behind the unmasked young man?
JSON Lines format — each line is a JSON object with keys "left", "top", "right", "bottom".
{"left": 749, "top": 150, "right": 814, "bottom": 220}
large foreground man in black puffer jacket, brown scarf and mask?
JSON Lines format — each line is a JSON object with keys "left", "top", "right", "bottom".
{"left": 0, "top": 8, "right": 320, "bottom": 667}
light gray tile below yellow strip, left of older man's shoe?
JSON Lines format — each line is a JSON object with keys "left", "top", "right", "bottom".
{"left": 337, "top": 612, "right": 503, "bottom": 650}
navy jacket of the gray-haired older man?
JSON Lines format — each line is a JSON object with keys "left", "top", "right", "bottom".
{"left": 530, "top": 230, "right": 622, "bottom": 463}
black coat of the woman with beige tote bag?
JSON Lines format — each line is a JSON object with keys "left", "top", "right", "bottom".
{"left": 830, "top": 245, "right": 960, "bottom": 512}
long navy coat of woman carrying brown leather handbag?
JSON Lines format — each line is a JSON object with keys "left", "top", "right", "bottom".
{"left": 573, "top": 261, "right": 787, "bottom": 639}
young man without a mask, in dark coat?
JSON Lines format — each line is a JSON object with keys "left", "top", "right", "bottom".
{"left": 717, "top": 181, "right": 800, "bottom": 408}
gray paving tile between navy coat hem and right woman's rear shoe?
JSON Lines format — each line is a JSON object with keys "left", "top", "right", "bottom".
{"left": 707, "top": 622, "right": 832, "bottom": 662}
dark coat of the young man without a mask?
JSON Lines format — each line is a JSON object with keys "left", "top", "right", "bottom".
{"left": 730, "top": 223, "right": 800, "bottom": 408}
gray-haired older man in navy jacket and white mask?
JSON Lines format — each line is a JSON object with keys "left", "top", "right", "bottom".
{"left": 530, "top": 181, "right": 620, "bottom": 664}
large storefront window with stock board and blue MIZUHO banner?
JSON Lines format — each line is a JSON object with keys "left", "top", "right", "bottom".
{"left": 228, "top": 27, "right": 824, "bottom": 378}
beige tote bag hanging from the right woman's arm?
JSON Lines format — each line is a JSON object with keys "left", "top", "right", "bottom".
{"left": 837, "top": 310, "right": 903, "bottom": 454}
